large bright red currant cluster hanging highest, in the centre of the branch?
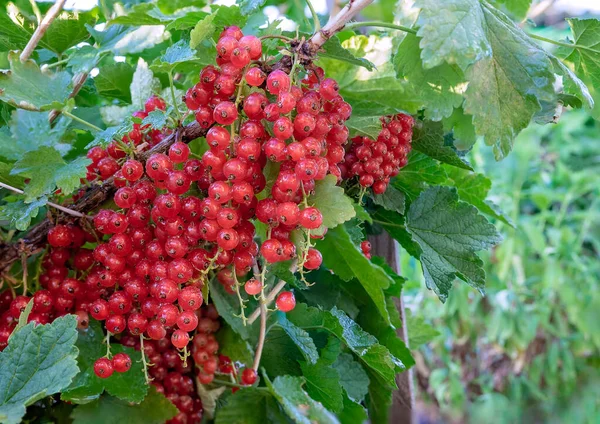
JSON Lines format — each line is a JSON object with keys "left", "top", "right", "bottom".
{"left": 181, "top": 26, "right": 352, "bottom": 300}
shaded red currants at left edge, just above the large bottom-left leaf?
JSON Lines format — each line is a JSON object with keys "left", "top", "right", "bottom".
{"left": 0, "top": 224, "right": 99, "bottom": 350}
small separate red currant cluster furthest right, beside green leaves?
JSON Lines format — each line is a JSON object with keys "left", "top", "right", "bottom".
{"left": 341, "top": 113, "right": 414, "bottom": 194}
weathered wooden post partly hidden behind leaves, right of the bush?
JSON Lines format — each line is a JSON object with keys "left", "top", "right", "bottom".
{"left": 369, "top": 232, "right": 416, "bottom": 424}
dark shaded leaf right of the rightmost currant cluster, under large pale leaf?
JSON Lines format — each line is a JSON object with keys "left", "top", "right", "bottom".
{"left": 412, "top": 121, "right": 473, "bottom": 171}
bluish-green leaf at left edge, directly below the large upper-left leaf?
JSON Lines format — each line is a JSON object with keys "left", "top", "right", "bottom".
{"left": 0, "top": 109, "right": 71, "bottom": 160}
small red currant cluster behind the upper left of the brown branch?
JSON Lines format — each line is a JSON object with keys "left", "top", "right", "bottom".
{"left": 86, "top": 96, "right": 169, "bottom": 185}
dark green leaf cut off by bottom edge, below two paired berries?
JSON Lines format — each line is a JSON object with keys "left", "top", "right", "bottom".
{"left": 71, "top": 387, "right": 179, "bottom": 424}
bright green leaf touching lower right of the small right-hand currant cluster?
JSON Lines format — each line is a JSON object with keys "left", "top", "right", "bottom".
{"left": 392, "top": 150, "right": 448, "bottom": 201}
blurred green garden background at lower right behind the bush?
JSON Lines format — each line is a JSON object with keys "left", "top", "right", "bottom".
{"left": 402, "top": 110, "right": 600, "bottom": 423}
